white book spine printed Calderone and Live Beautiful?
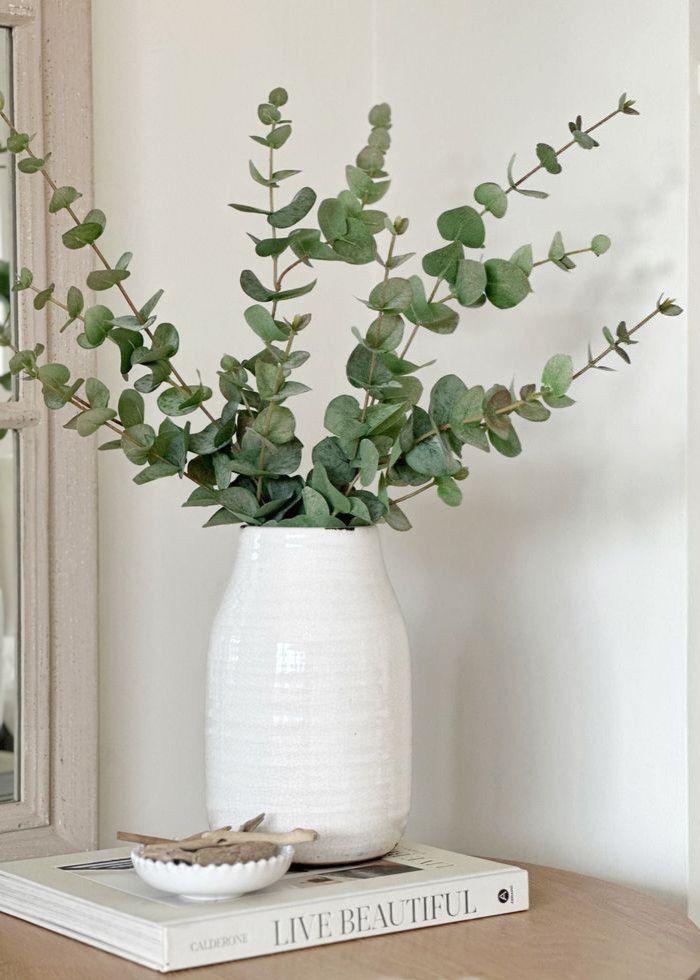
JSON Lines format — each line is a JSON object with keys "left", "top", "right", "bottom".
{"left": 164, "top": 869, "right": 528, "bottom": 972}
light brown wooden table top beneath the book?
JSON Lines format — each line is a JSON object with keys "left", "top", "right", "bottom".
{"left": 0, "top": 862, "right": 700, "bottom": 980}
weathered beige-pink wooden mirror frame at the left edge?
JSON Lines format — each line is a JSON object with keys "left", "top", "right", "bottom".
{"left": 0, "top": 0, "right": 98, "bottom": 860}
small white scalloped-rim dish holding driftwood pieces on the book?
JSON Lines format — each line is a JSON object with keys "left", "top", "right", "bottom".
{"left": 131, "top": 844, "right": 294, "bottom": 902}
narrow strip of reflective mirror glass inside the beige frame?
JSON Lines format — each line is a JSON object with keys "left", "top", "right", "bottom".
{"left": 0, "top": 28, "right": 20, "bottom": 802}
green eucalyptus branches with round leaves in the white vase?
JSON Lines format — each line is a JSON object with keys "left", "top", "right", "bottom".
{"left": 0, "top": 88, "right": 681, "bottom": 531}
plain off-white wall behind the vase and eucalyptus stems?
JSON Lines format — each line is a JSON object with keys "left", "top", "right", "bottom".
{"left": 93, "top": 0, "right": 687, "bottom": 901}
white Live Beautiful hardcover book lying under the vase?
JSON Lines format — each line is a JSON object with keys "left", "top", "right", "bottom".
{"left": 0, "top": 841, "right": 528, "bottom": 973}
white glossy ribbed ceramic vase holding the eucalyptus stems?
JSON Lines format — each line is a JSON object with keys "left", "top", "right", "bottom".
{"left": 206, "top": 527, "right": 411, "bottom": 864}
